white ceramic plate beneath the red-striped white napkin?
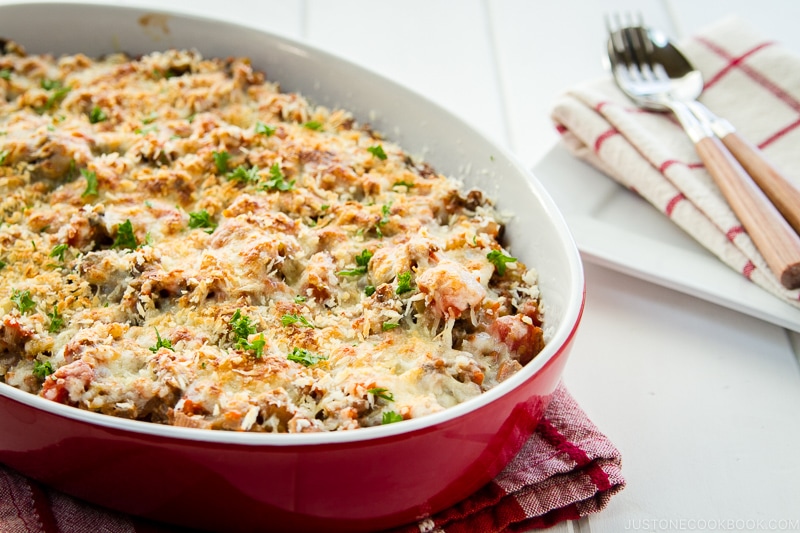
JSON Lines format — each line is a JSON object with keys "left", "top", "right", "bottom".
{"left": 534, "top": 145, "right": 800, "bottom": 332}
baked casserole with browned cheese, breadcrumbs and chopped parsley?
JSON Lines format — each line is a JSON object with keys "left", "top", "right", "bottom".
{"left": 0, "top": 43, "right": 543, "bottom": 432}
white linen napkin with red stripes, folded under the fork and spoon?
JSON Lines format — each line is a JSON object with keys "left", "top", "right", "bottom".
{"left": 551, "top": 17, "right": 800, "bottom": 307}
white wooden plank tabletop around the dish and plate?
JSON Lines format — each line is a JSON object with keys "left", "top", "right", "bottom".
{"left": 6, "top": 0, "right": 800, "bottom": 533}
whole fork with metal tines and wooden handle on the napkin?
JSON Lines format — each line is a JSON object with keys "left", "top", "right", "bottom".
{"left": 606, "top": 15, "right": 800, "bottom": 289}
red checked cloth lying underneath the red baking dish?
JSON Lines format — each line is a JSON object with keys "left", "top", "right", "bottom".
{"left": 0, "top": 385, "right": 625, "bottom": 533}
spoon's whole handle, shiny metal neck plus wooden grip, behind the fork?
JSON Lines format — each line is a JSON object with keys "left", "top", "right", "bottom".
{"left": 690, "top": 101, "right": 800, "bottom": 234}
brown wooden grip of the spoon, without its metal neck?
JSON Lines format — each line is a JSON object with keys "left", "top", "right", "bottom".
{"left": 722, "top": 132, "right": 800, "bottom": 234}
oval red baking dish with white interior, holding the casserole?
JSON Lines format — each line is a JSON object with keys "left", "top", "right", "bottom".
{"left": 0, "top": 3, "right": 584, "bottom": 531}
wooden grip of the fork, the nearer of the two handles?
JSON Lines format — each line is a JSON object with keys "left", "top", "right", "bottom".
{"left": 695, "top": 137, "right": 800, "bottom": 289}
